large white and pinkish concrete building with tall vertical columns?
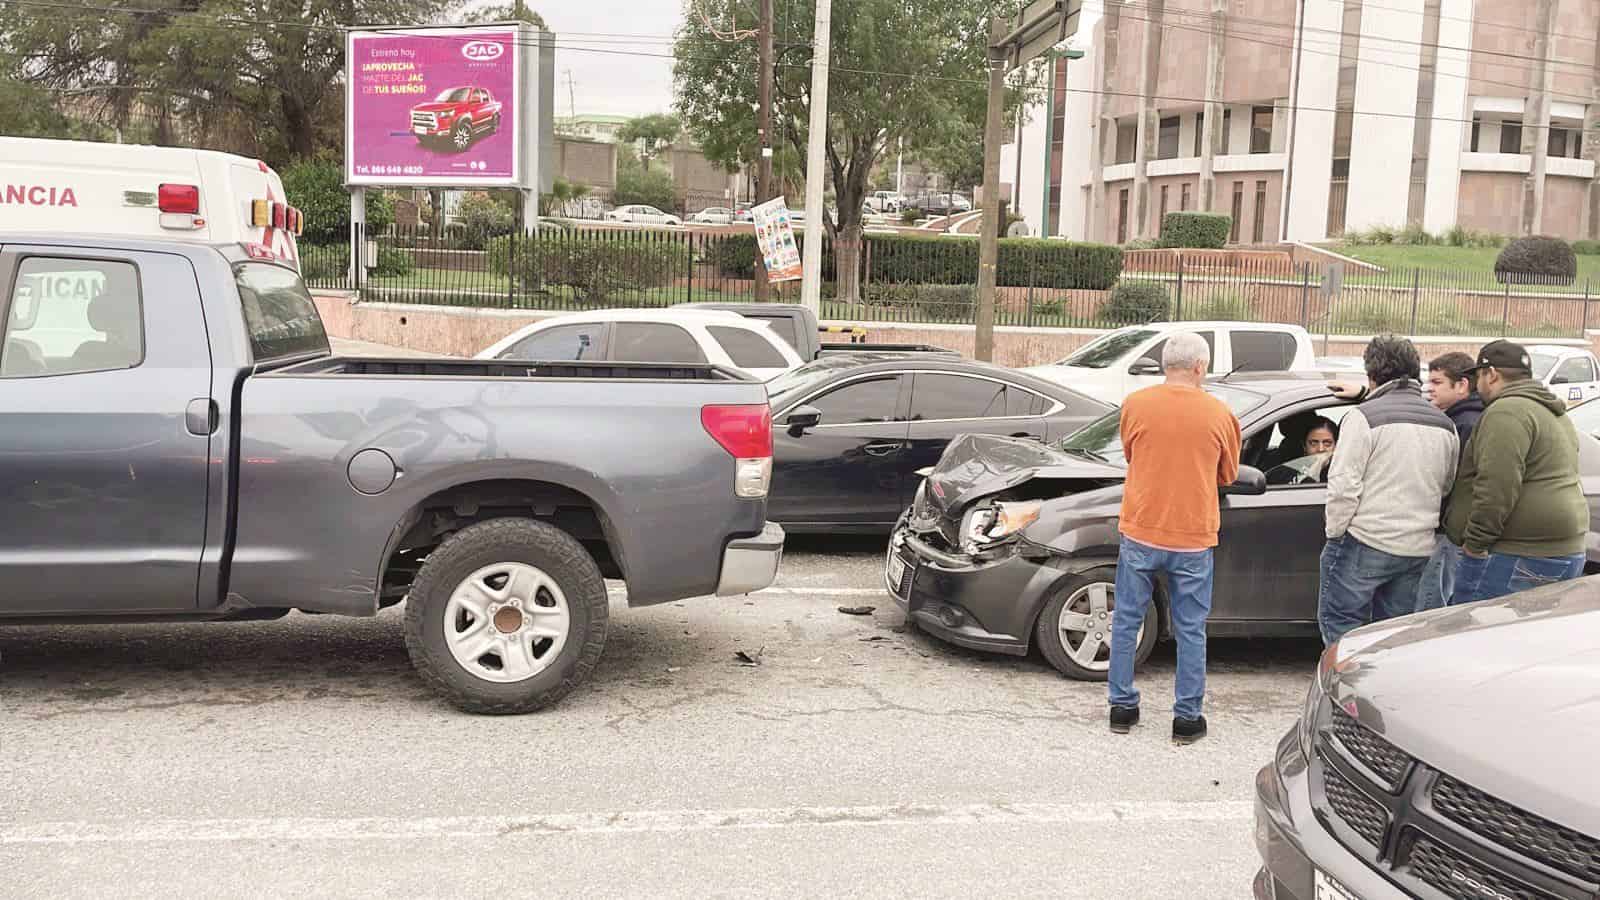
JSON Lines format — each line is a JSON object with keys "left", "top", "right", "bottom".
{"left": 1002, "top": 0, "right": 1600, "bottom": 245}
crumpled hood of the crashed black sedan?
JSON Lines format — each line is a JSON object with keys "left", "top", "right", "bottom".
{"left": 926, "top": 434, "right": 1128, "bottom": 517}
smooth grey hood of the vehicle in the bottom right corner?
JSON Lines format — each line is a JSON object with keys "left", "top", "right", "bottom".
{"left": 1328, "top": 577, "right": 1600, "bottom": 836}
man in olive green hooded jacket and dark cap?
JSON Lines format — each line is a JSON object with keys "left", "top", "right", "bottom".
{"left": 1445, "top": 341, "right": 1589, "bottom": 605}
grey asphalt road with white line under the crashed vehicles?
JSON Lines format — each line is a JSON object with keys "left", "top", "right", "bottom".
{"left": 0, "top": 541, "right": 1317, "bottom": 898}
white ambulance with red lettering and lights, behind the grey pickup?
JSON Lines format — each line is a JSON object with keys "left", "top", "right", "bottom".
{"left": 0, "top": 138, "right": 304, "bottom": 269}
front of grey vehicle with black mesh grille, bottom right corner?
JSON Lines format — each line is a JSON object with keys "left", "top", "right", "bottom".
{"left": 1254, "top": 578, "right": 1600, "bottom": 900}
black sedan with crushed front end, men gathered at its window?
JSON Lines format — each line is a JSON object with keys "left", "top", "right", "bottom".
{"left": 885, "top": 373, "right": 1600, "bottom": 681}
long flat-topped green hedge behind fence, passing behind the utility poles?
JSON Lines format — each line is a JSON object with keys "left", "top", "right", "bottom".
{"left": 702, "top": 234, "right": 1122, "bottom": 290}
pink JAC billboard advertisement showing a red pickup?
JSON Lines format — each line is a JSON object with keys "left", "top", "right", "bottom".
{"left": 346, "top": 27, "right": 522, "bottom": 186}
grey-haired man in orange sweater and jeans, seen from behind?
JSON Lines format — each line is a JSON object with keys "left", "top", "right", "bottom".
{"left": 1109, "top": 333, "right": 1240, "bottom": 743}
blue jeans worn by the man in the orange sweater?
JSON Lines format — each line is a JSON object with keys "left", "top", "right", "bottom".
{"left": 1107, "top": 538, "right": 1211, "bottom": 719}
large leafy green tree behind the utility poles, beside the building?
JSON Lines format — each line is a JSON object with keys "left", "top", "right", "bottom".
{"left": 674, "top": 0, "right": 1032, "bottom": 301}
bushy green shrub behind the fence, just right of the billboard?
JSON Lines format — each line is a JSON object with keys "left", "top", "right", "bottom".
{"left": 488, "top": 234, "right": 682, "bottom": 303}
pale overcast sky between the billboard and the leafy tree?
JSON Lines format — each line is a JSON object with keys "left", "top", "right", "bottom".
{"left": 544, "top": 0, "right": 683, "bottom": 117}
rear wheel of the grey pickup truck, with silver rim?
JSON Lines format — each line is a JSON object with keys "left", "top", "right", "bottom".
{"left": 405, "top": 519, "right": 610, "bottom": 714}
